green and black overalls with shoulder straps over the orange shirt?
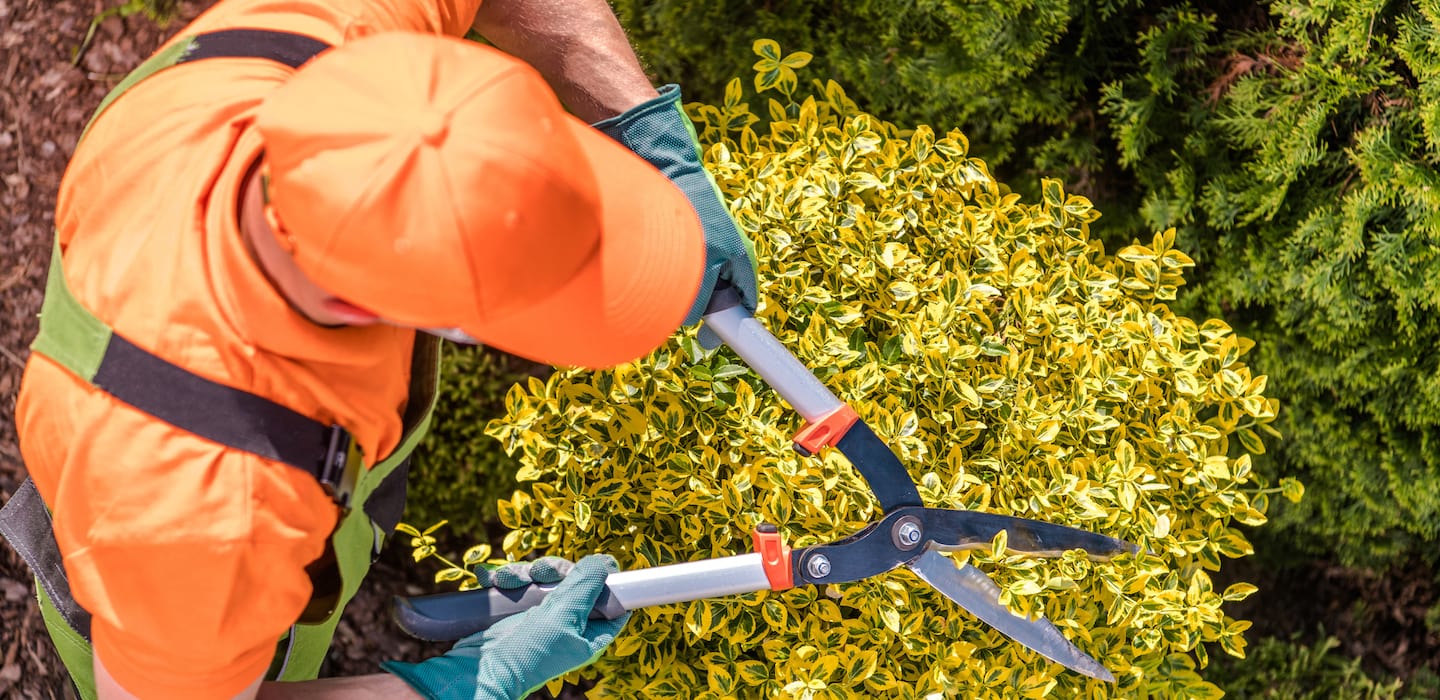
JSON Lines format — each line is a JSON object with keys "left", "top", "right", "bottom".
{"left": 0, "top": 29, "right": 439, "bottom": 700}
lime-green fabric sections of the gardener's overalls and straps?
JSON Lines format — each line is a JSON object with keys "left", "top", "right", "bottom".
{"left": 32, "top": 31, "right": 439, "bottom": 700}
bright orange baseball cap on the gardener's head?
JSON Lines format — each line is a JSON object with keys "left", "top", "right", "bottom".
{"left": 256, "top": 33, "right": 704, "bottom": 367}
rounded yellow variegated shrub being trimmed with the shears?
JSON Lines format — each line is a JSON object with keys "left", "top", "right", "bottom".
{"left": 466, "top": 42, "right": 1299, "bottom": 699}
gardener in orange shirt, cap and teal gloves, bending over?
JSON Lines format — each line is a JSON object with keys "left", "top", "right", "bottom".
{"left": 3, "top": 0, "right": 755, "bottom": 699}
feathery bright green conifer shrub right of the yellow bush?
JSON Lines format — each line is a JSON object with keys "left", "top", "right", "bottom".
{"left": 1106, "top": 0, "right": 1440, "bottom": 567}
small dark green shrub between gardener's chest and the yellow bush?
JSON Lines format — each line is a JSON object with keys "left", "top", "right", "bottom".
{"left": 405, "top": 343, "right": 550, "bottom": 540}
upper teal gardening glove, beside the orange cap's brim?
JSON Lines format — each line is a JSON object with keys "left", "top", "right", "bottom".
{"left": 595, "top": 85, "right": 759, "bottom": 326}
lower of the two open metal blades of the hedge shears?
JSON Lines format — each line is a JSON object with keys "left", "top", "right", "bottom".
{"left": 907, "top": 549, "right": 1115, "bottom": 683}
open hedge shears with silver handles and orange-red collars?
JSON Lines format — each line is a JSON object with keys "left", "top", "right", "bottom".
{"left": 395, "top": 287, "right": 1139, "bottom": 683}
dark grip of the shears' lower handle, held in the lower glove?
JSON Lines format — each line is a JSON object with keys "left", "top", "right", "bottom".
{"left": 392, "top": 583, "right": 625, "bottom": 641}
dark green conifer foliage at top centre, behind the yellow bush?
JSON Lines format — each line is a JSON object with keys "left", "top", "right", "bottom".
{"left": 613, "top": 0, "right": 1163, "bottom": 201}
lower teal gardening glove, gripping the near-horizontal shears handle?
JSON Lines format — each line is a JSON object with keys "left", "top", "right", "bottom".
{"left": 380, "top": 555, "right": 629, "bottom": 700}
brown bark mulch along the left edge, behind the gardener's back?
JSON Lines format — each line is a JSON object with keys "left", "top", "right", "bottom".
{"left": 0, "top": 0, "right": 109, "bottom": 688}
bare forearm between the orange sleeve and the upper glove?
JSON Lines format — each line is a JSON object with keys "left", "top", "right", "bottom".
{"left": 474, "top": 0, "right": 657, "bottom": 122}
